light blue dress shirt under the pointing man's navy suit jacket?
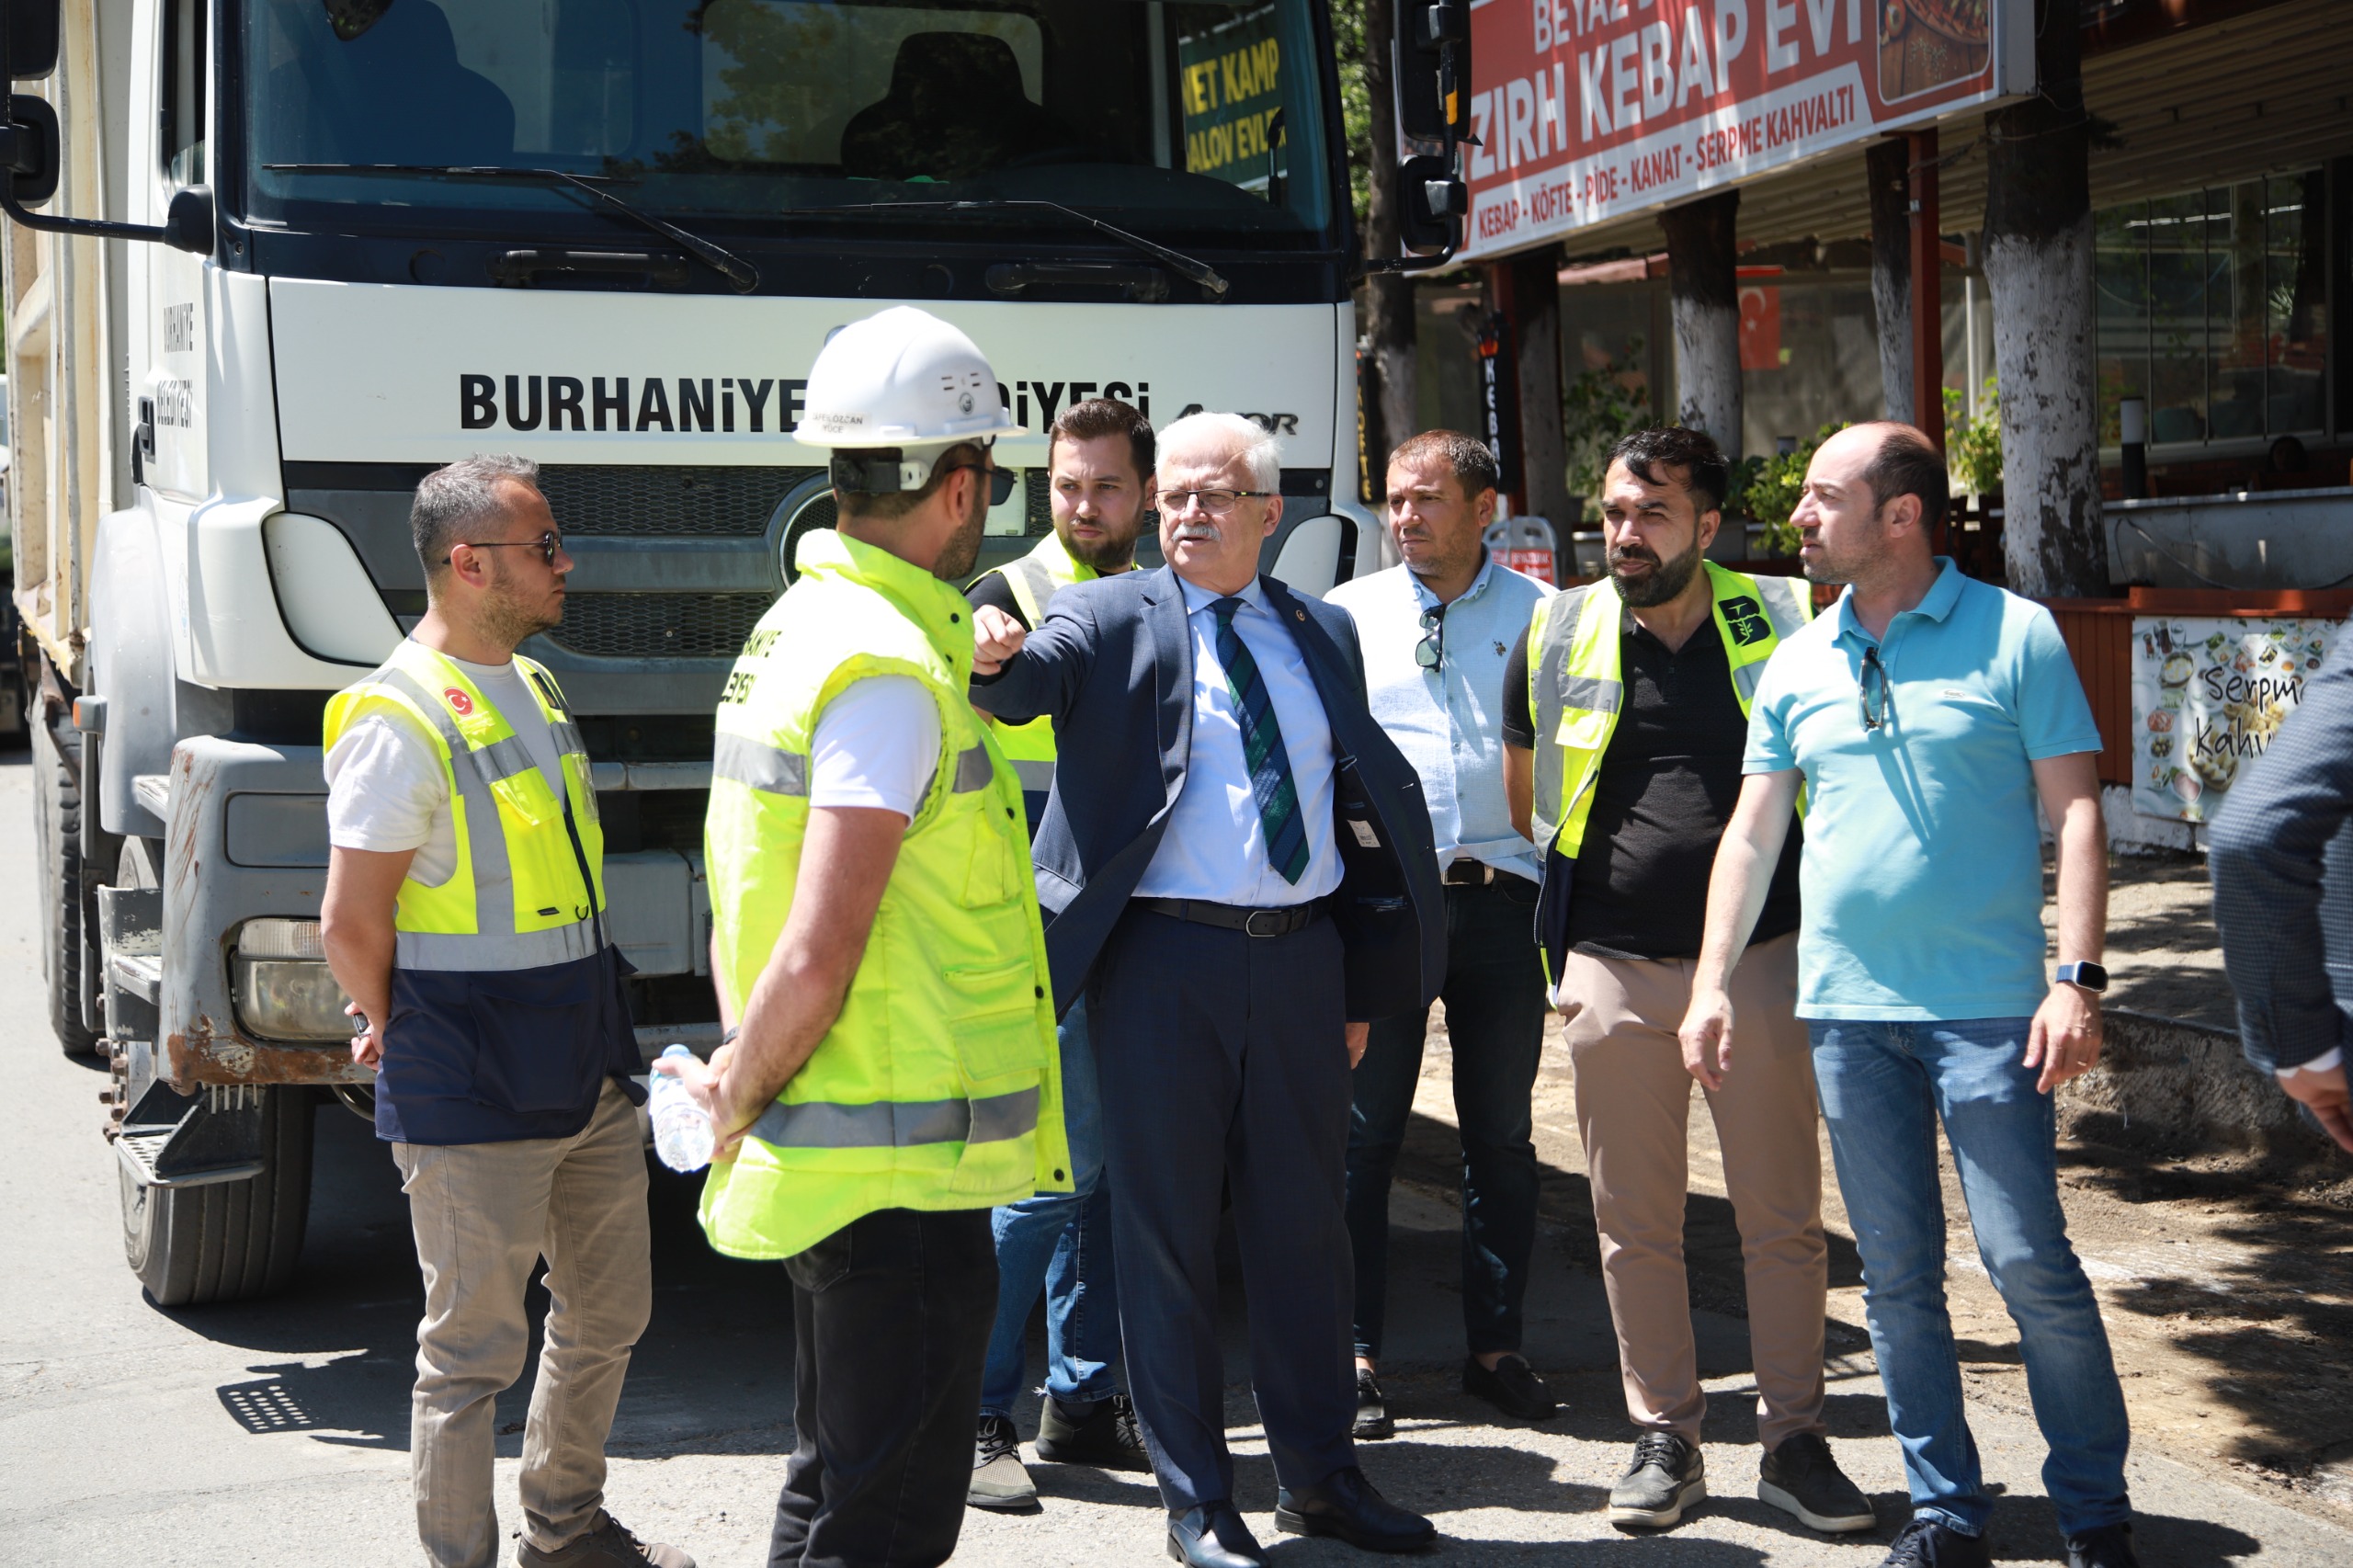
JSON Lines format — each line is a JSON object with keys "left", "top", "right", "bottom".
{"left": 1136, "top": 577, "right": 1341, "bottom": 909}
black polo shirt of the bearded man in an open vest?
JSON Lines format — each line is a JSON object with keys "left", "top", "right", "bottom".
{"left": 1504, "top": 615, "right": 1802, "bottom": 959}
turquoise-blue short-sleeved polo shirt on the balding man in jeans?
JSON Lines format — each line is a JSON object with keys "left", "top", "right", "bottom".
{"left": 1741, "top": 556, "right": 2099, "bottom": 1019}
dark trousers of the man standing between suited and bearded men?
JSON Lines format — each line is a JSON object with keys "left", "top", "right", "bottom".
{"left": 1348, "top": 876, "right": 1546, "bottom": 1361}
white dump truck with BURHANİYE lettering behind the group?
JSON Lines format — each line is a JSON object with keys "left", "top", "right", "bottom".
{"left": 0, "top": 0, "right": 1468, "bottom": 1304}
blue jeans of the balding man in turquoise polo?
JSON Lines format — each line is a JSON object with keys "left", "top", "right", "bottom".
{"left": 1807, "top": 1017, "right": 2131, "bottom": 1535}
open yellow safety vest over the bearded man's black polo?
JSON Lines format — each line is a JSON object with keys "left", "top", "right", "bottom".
{"left": 1527, "top": 561, "right": 1814, "bottom": 864}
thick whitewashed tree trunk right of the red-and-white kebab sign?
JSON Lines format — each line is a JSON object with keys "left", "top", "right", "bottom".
{"left": 1986, "top": 18, "right": 2109, "bottom": 598}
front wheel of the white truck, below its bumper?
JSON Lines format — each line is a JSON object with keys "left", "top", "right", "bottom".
{"left": 115, "top": 1087, "right": 313, "bottom": 1307}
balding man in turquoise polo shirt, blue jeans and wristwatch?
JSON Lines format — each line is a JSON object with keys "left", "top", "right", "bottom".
{"left": 1682, "top": 424, "right": 2136, "bottom": 1568}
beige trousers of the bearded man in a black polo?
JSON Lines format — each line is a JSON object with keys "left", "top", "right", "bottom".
{"left": 1560, "top": 935, "right": 1831, "bottom": 1448}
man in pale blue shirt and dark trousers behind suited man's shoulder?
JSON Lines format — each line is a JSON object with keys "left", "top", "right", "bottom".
{"left": 1329, "top": 431, "right": 1555, "bottom": 1438}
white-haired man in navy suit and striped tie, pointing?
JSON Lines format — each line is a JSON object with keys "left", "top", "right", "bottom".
{"left": 972, "top": 415, "right": 1445, "bottom": 1568}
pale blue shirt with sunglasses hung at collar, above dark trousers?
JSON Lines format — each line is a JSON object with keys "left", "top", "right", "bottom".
{"left": 1324, "top": 548, "right": 1553, "bottom": 883}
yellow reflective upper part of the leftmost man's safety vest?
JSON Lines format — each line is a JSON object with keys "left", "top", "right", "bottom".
{"left": 324, "top": 638, "right": 605, "bottom": 970}
